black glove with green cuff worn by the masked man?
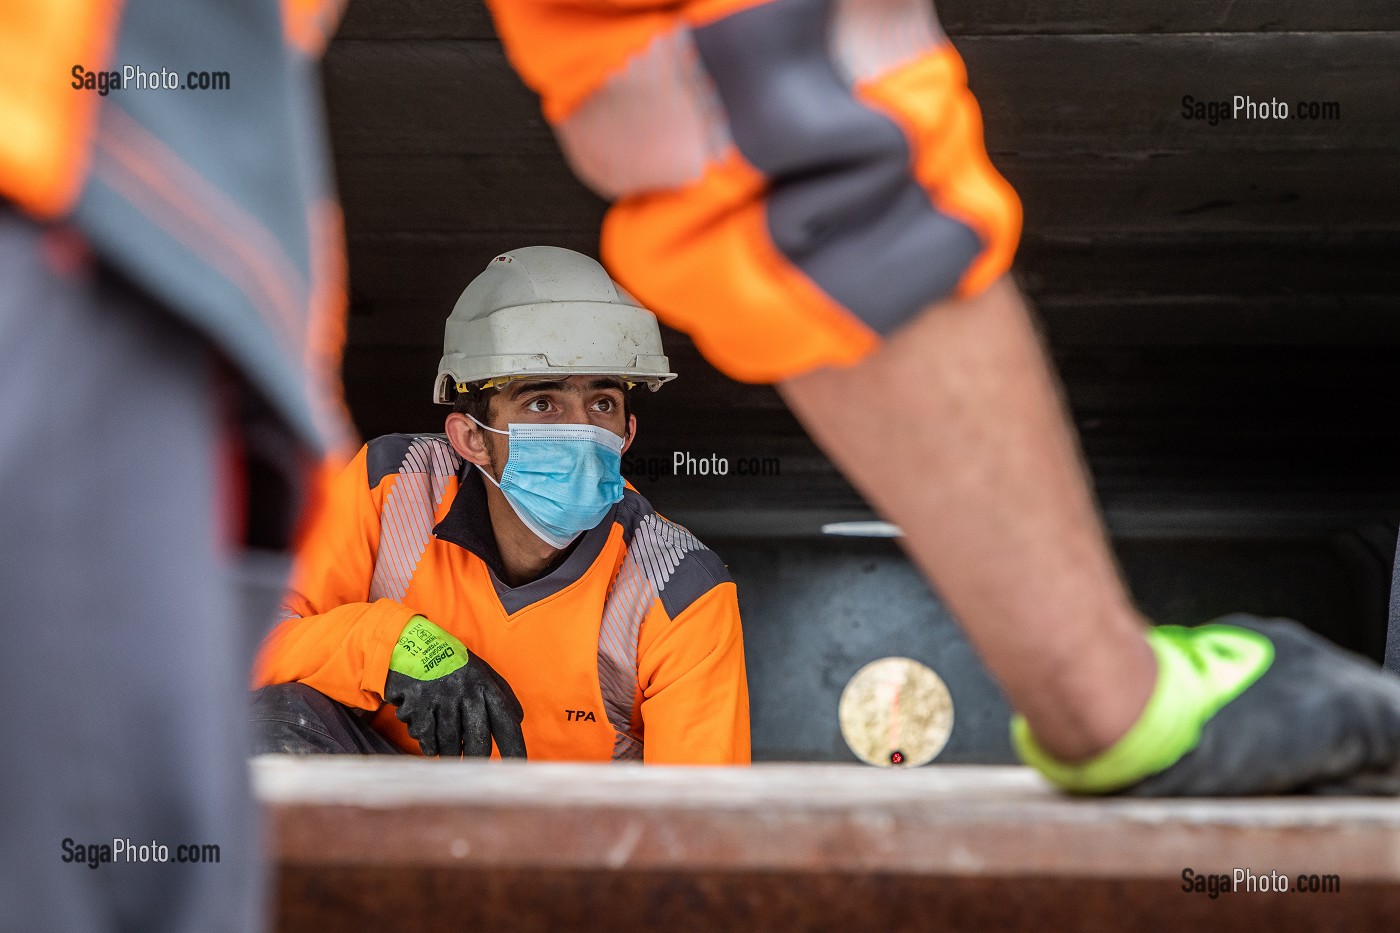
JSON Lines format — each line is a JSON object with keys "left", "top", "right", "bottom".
{"left": 384, "top": 615, "right": 525, "bottom": 758}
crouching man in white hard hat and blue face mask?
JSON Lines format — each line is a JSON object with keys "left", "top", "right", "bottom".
{"left": 253, "top": 247, "right": 749, "bottom": 763}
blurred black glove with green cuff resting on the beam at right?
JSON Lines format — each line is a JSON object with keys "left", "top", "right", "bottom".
{"left": 1014, "top": 615, "right": 1400, "bottom": 797}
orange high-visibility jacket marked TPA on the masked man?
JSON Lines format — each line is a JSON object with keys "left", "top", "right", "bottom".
{"left": 253, "top": 434, "right": 749, "bottom": 763}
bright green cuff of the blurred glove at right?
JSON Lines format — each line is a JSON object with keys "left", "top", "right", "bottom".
{"left": 1011, "top": 625, "right": 1274, "bottom": 794}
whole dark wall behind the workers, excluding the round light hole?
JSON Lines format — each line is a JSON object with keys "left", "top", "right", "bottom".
{"left": 325, "top": 0, "right": 1400, "bottom": 759}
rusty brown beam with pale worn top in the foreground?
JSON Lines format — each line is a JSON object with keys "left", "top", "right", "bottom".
{"left": 253, "top": 758, "right": 1400, "bottom": 930}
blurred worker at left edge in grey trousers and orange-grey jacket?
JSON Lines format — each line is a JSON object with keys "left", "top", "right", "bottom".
{"left": 0, "top": 0, "right": 350, "bottom": 933}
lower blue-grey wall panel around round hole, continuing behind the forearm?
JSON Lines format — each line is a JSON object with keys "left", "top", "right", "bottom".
{"left": 722, "top": 529, "right": 1390, "bottom": 763}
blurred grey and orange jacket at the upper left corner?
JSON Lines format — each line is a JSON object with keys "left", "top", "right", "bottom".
{"left": 0, "top": 0, "right": 350, "bottom": 454}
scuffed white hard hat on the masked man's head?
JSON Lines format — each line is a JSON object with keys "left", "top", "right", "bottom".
{"left": 433, "top": 247, "right": 676, "bottom": 405}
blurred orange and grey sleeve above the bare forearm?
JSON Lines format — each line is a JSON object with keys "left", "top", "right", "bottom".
{"left": 489, "top": 0, "right": 1021, "bottom": 381}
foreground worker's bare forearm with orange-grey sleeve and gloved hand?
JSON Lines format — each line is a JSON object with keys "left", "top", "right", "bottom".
{"left": 489, "top": 0, "right": 1400, "bottom": 794}
